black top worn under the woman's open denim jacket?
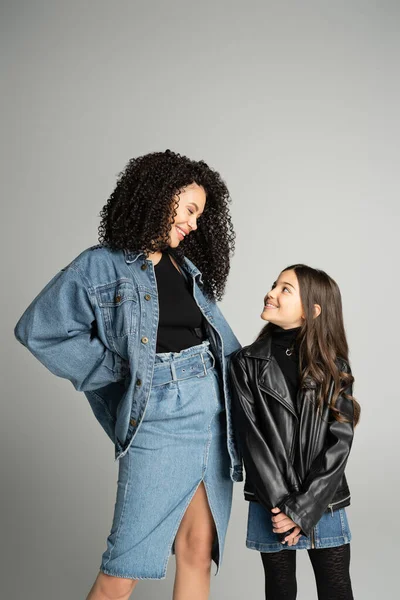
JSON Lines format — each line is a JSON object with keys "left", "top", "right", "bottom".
{"left": 154, "top": 252, "right": 205, "bottom": 352}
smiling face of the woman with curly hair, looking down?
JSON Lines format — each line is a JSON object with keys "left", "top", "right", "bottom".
{"left": 169, "top": 183, "right": 206, "bottom": 248}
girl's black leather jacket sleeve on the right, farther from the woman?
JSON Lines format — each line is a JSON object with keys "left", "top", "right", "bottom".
{"left": 278, "top": 367, "right": 354, "bottom": 535}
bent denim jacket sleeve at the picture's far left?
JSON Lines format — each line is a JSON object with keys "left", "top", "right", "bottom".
{"left": 14, "top": 265, "right": 128, "bottom": 391}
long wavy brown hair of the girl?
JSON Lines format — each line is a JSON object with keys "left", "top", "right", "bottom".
{"left": 257, "top": 264, "right": 360, "bottom": 425}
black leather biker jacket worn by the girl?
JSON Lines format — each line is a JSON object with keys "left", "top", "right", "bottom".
{"left": 230, "top": 337, "right": 353, "bottom": 535}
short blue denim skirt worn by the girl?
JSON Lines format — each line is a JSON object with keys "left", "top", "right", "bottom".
{"left": 246, "top": 502, "right": 351, "bottom": 552}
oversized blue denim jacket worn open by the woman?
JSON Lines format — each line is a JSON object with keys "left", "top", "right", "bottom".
{"left": 15, "top": 246, "right": 242, "bottom": 481}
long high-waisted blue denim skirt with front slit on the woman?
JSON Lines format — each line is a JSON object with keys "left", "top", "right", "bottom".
{"left": 100, "top": 342, "right": 232, "bottom": 579}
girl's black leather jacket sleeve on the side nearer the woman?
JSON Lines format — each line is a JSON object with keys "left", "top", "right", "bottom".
{"left": 230, "top": 354, "right": 298, "bottom": 510}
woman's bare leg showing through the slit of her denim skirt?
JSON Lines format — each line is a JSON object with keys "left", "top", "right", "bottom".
{"left": 173, "top": 483, "right": 216, "bottom": 600}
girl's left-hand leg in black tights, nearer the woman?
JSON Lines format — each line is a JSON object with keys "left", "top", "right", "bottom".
{"left": 261, "top": 550, "right": 297, "bottom": 600}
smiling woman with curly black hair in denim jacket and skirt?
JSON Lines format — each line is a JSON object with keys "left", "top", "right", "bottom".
{"left": 15, "top": 150, "right": 241, "bottom": 600}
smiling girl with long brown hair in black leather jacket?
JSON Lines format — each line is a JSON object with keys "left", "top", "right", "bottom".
{"left": 231, "top": 265, "right": 360, "bottom": 600}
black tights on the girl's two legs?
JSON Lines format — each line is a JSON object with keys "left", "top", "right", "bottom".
{"left": 261, "top": 544, "right": 353, "bottom": 600}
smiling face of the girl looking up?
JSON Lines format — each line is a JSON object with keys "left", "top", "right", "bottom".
{"left": 261, "top": 270, "right": 304, "bottom": 329}
